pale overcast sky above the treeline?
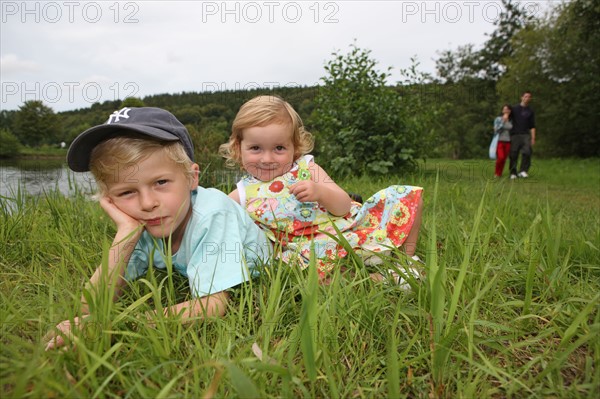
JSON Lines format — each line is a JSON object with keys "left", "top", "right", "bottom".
{"left": 0, "top": 0, "right": 556, "bottom": 111}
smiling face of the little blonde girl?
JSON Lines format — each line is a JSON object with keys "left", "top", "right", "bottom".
{"left": 240, "top": 123, "right": 294, "bottom": 181}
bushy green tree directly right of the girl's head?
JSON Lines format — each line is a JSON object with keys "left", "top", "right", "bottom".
{"left": 309, "top": 45, "right": 415, "bottom": 175}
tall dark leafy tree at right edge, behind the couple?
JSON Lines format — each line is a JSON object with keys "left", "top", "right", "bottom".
{"left": 498, "top": 0, "right": 600, "bottom": 157}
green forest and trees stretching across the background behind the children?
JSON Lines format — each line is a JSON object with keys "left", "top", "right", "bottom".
{"left": 0, "top": 0, "right": 600, "bottom": 176}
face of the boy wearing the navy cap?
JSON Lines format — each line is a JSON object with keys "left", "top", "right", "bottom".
{"left": 107, "top": 151, "right": 198, "bottom": 244}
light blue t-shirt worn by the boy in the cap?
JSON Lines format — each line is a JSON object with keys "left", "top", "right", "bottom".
{"left": 125, "top": 187, "right": 272, "bottom": 297}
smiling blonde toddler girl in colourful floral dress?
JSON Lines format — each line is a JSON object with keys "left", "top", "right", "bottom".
{"left": 220, "top": 96, "right": 423, "bottom": 281}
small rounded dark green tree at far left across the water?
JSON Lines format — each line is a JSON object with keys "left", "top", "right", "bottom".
{"left": 13, "top": 100, "right": 62, "bottom": 147}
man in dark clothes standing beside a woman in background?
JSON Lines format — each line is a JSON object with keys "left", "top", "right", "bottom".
{"left": 509, "top": 91, "right": 536, "bottom": 179}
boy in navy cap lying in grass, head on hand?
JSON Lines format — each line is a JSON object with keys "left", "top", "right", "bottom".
{"left": 46, "top": 107, "right": 270, "bottom": 349}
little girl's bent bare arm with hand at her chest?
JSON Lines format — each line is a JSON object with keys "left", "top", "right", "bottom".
{"left": 290, "top": 163, "right": 352, "bottom": 216}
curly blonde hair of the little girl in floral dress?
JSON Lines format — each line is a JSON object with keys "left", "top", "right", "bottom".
{"left": 219, "top": 96, "right": 314, "bottom": 166}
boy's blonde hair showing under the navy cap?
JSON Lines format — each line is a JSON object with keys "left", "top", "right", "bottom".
{"left": 90, "top": 135, "right": 194, "bottom": 195}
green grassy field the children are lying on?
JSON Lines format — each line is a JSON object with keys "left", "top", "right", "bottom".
{"left": 0, "top": 159, "right": 600, "bottom": 398}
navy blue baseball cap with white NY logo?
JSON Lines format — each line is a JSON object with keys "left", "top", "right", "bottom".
{"left": 67, "top": 107, "right": 194, "bottom": 172}
